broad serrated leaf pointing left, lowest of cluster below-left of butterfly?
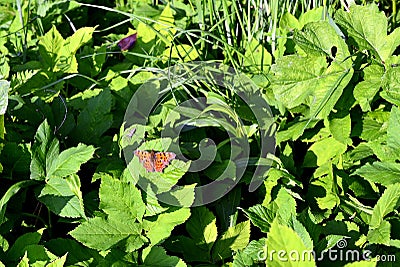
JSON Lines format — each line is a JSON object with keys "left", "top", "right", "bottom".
{"left": 69, "top": 217, "right": 143, "bottom": 250}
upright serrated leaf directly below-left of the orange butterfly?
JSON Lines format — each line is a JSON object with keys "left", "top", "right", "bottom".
{"left": 99, "top": 174, "right": 146, "bottom": 221}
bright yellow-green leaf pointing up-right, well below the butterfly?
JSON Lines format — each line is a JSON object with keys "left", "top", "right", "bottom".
{"left": 144, "top": 208, "right": 190, "bottom": 245}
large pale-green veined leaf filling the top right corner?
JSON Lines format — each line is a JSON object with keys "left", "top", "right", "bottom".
{"left": 335, "top": 4, "right": 400, "bottom": 62}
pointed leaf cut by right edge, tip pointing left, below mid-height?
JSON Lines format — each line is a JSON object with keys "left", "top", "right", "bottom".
{"left": 354, "top": 162, "right": 400, "bottom": 186}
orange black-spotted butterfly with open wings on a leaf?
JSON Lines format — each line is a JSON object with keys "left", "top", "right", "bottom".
{"left": 133, "top": 150, "right": 176, "bottom": 172}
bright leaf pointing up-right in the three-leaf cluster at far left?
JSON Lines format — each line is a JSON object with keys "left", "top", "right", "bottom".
{"left": 46, "top": 144, "right": 95, "bottom": 180}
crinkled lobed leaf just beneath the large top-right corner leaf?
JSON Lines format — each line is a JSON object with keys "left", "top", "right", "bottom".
{"left": 353, "top": 64, "right": 384, "bottom": 112}
